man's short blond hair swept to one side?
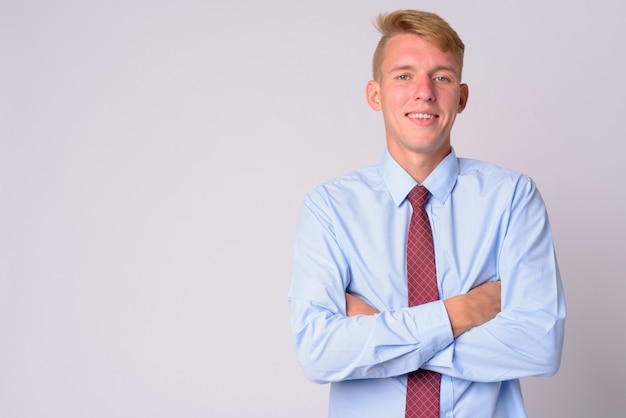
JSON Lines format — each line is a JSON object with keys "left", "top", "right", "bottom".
{"left": 372, "top": 10, "right": 465, "bottom": 81}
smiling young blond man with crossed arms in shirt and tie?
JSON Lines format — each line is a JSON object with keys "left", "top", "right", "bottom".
{"left": 289, "top": 10, "right": 565, "bottom": 418}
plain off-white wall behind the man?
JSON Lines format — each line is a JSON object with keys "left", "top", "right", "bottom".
{"left": 0, "top": 0, "right": 626, "bottom": 418}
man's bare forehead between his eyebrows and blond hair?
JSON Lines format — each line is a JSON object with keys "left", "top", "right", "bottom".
{"left": 381, "top": 33, "right": 461, "bottom": 74}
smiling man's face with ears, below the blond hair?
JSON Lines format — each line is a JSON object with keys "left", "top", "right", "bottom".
{"left": 367, "top": 34, "right": 468, "bottom": 166}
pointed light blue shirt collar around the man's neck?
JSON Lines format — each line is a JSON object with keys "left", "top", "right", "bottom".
{"left": 380, "top": 148, "right": 459, "bottom": 206}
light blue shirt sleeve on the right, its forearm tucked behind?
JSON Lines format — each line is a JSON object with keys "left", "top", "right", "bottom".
{"left": 424, "top": 177, "right": 565, "bottom": 382}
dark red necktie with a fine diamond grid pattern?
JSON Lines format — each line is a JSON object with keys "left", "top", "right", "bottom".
{"left": 405, "top": 186, "right": 441, "bottom": 418}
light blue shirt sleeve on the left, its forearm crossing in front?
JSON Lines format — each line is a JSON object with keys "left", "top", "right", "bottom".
{"left": 288, "top": 191, "right": 452, "bottom": 383}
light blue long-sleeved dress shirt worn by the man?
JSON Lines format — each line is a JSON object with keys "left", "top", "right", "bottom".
{"left": 289, "top": 151, "right": 565, "bottom": 418}
